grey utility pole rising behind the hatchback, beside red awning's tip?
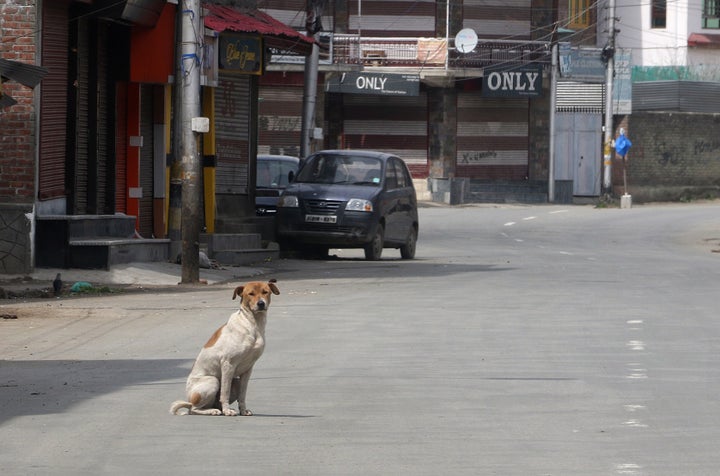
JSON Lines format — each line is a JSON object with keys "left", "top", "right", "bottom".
{"left": 300, "top": 0, "right": 327, "bottom": 159}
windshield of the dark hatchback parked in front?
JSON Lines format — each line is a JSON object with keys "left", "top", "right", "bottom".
{"left": 295, "top": 154, "right": 382, "bottom": 186}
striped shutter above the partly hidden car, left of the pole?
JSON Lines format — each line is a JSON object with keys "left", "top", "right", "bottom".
{"left": 258, "top": 86, "right": 303, "bottom": 157}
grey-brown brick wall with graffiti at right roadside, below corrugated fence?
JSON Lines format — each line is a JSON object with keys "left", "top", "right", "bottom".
{"left": 613, "top": 112, "right": 720, "bottom": 202}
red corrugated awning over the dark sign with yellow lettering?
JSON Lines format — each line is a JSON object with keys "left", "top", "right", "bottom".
{"left": 203, "top": 3, "right": 314, "bottom": 55}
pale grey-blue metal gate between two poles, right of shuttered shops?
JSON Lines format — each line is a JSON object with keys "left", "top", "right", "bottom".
{"left": 555, "top": 113, "right": 602, "bottom": 197}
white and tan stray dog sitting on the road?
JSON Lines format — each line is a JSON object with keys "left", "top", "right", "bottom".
{"left": 170, "top": 279, "right": 280, "bottom": 416}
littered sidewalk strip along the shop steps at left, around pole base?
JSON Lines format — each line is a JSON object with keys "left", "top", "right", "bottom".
{"left": 0, "top": 261, "right": 268, "bottom": 303}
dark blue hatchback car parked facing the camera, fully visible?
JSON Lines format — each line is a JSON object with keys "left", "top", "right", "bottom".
{"left": 277, "top": 150, "right": 418, "bottom": 260}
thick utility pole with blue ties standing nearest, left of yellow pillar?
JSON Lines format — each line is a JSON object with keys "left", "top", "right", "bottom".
{"left": 177, "top": 0, "right": 203, "bottom": 284}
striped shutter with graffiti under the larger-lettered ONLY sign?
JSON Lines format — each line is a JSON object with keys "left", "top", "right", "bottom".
{"left": 456, "top": 91, "right": 529, "bottom": 180}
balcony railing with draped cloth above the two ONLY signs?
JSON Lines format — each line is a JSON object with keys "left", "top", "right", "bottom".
{"left": 331, "top": 34, "right": 550, "bottom": 68}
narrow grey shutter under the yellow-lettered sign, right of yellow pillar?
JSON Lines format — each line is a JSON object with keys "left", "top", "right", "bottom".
{"left": 215, "top": 72, "right": 250, "bottom": 194}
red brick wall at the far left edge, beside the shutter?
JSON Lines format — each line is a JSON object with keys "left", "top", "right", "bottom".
{"left": 0, "top": 0, "right": 37, "bottom": 203}
